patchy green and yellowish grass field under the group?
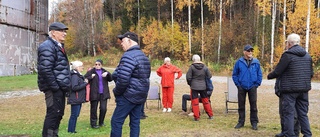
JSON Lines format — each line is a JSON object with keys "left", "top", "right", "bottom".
{"left": 0, "top": 75, "right": 320, "bottom": 137}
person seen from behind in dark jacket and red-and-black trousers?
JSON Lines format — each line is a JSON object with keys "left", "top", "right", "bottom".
{"left": 186, "top": 54, "right": 213, "bottom": 121}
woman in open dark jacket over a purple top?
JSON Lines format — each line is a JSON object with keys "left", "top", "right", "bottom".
{"left": 84, "top": 59, "right": 112, "bottom": 128}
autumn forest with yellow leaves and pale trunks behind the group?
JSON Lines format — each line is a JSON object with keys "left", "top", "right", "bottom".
{"left": 50, "top": 0, "right": 320, "bottom": 73}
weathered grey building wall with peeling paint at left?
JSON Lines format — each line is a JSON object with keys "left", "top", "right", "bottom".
{"left": 0, "top": 0, "right": 48, "bottom": 76}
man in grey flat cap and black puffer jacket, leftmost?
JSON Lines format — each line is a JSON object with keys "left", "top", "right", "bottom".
{"left": 38, "top": 22, "right": 71, "bottom": 137}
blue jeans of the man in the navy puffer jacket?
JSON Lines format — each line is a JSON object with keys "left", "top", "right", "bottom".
{"left": 110, "top": 96, "right": 143, "bottom": 137}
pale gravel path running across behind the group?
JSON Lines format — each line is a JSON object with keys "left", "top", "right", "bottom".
{"left": 0, "top": 71, "right": 320, "bottom": 99}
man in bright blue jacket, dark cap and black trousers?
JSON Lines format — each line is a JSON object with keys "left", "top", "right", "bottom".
{"left": 232, "top": 45, "right": 262, "bottom": 130}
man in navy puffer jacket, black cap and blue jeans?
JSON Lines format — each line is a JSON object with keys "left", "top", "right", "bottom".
{"left": 110, "top": 32, "right": 151, "bottom": 137}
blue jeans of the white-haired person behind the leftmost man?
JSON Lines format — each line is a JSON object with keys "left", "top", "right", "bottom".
{"left": 68, "top": 104, "right": 82, "bottom": 133}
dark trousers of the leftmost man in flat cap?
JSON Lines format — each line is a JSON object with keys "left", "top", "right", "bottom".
{"left": 42, "top": 90, "right": 66, "bottom": 137}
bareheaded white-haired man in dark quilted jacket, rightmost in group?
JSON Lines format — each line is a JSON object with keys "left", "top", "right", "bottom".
{"left": 268, "top": 33, "right": 313, "bottom": 137}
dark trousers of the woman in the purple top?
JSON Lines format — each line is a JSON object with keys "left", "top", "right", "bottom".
{"left": 90, "top": 94, "right": 107, "bottom": 126}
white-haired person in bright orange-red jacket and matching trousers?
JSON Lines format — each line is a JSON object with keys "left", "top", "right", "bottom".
{"left": 157, "top": 57, "right": 182, "bottom": 112}
